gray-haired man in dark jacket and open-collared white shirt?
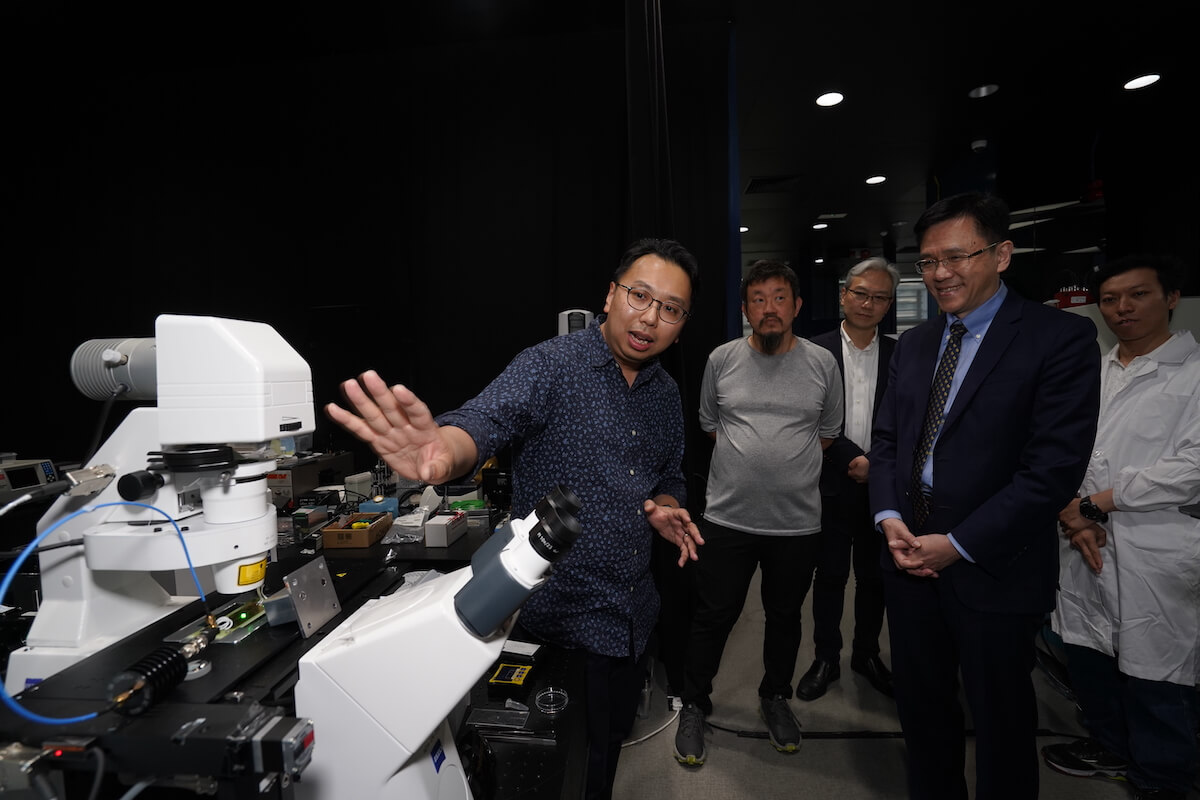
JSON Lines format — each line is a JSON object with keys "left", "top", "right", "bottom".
{"left": 796, "top": 258, "right": 900, "bottom": 700}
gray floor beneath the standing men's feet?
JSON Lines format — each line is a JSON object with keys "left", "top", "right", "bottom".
{"left": 613, "top": 582, "right": 1200, "bottom": 800}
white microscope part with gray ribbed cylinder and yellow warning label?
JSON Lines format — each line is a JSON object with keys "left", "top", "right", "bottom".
{"left": 5, "top": 314, "right": 316, "bottom": 694}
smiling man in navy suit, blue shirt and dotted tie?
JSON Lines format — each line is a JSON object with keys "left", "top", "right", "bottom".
{"left": 870, "top": 193, "right": 1099, "bottom": 800}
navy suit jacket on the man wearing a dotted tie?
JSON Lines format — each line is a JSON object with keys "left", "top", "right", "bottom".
{"left": 869, "top": 290, "right": 1100, "bottom": 613}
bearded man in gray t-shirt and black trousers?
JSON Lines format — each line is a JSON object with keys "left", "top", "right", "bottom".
{"left": 674, "top": 261, "right": 842, "bottom": 766}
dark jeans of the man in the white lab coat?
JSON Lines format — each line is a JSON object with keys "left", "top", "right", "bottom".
{"left": 1064, "top": 644, "right": 1198, "bottom": 794}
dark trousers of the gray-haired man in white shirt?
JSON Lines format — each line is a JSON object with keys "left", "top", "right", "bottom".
{"left": 812, "top": 483, "right": 883, "bottom": 663}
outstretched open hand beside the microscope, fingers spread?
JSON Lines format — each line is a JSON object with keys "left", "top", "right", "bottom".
{"left": 325, "top": 369, "right": 479, "bottom": 483}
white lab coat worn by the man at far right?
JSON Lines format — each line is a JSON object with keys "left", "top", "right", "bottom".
{"left": 1052, "top": 331, "right": 1200, "bottom": 686}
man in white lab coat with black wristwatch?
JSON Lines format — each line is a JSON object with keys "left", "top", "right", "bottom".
{"left": 1042, "top": 257, "right": 1200, "bottom": 800}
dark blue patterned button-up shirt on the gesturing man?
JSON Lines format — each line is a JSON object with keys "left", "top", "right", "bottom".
{"left": 438, "top": 317, "right": 686, "bottom": 656}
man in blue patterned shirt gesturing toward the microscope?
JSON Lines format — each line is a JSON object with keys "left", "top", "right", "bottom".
{"left": 326, "top": 239, "right": 703, "bottom": 798}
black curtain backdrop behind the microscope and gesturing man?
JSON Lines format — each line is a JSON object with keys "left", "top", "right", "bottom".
{"left": 0, "top": 2, "right": 738, "bottom": 501}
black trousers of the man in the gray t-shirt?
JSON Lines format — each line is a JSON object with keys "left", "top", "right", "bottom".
{"left": 683, "top": 519, "right": 821, "bottom": 714}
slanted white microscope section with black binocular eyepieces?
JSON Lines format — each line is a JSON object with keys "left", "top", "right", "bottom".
{"left": 295, "top": 487, "right": 580, "bottom": 800}
